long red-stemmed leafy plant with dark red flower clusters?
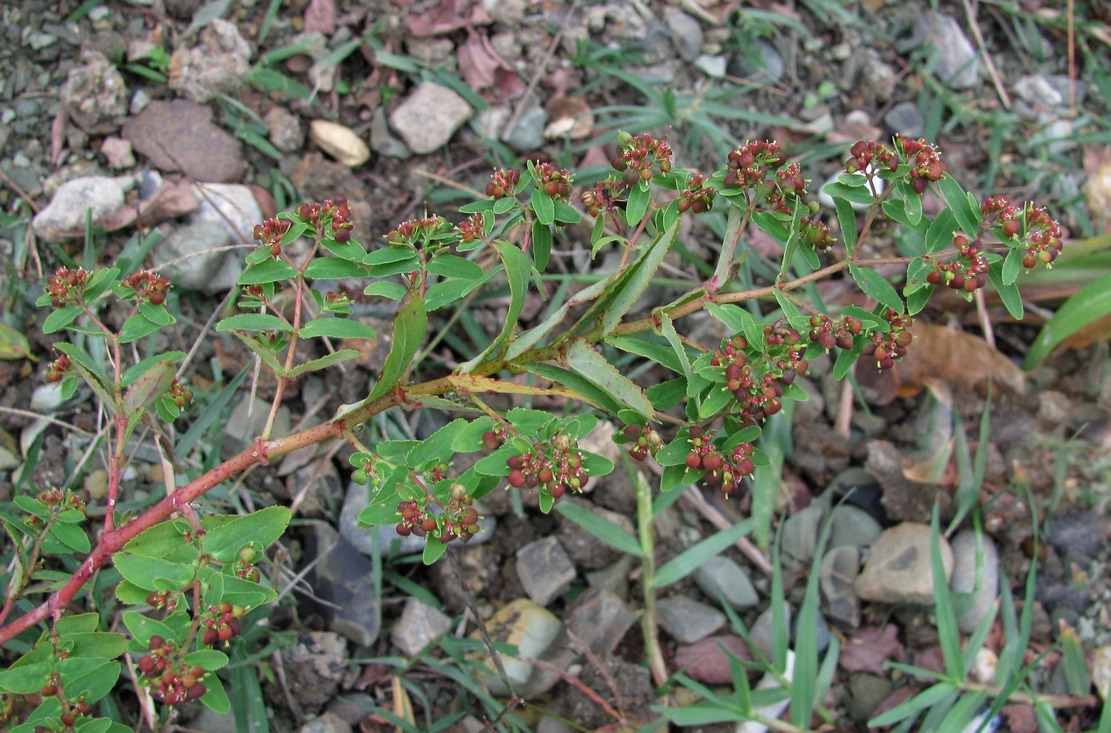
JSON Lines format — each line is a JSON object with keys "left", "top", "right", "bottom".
{"left": 0, "top": 133, "right": 1062, "bottom": 730}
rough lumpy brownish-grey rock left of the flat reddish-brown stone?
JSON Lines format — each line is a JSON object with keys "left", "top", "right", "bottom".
{"left": 60, "top": 51, "right": 128, "bottom": 133}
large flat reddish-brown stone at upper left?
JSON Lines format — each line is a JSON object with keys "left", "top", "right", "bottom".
{"left": 122, "top": 99, "right": 243, "bottom": 183}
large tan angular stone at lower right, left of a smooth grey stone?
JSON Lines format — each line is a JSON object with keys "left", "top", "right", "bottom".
{"left": 853, "top": 522, "right": 953, "bottom": 605}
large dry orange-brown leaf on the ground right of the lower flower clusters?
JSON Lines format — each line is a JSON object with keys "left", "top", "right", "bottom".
{"left": 892, "top": 322, "right": 1027, "bottom": 398}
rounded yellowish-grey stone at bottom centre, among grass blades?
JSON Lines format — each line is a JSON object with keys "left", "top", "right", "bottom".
{"left": 471, "top": 599, "right": 562, "bottom": 695}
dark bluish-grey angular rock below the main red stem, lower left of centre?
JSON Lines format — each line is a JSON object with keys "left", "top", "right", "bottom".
{"left": 306, "top": 522, "right": 382, "bottom": 646}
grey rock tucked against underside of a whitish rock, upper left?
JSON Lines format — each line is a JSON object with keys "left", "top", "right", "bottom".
{"left": 153, "top": 221, "right": 233, "bottom": 293}
